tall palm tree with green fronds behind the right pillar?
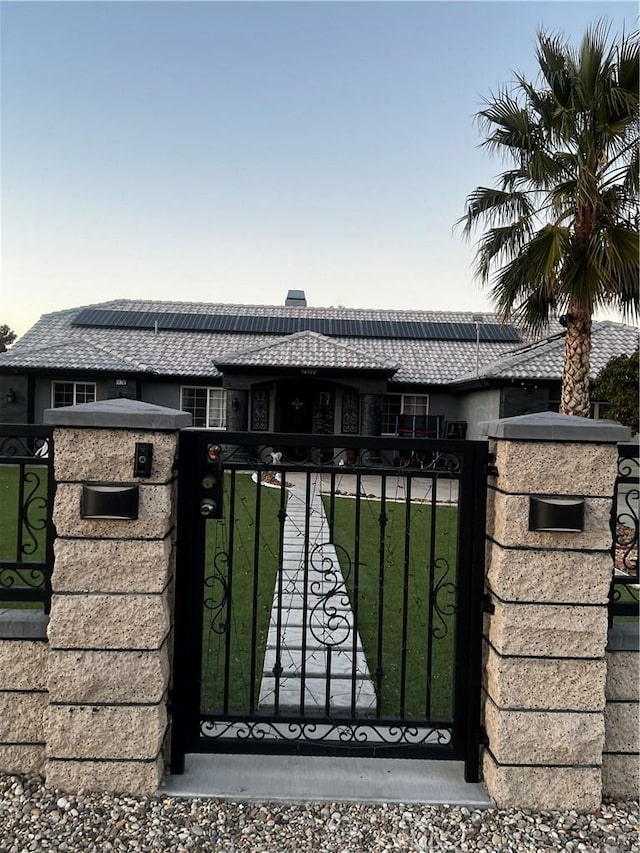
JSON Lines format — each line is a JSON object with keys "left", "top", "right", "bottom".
{"left": 458, "top": 22, "right": 639, "bottom": 417}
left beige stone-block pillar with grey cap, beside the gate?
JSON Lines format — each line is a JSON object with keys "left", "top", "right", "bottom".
{"left": 45, "top": 399, "right": 191, "bottom": 794}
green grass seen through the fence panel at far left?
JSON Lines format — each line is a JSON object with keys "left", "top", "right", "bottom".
{"left": 0, "top": 465, "right": 48, "bottom": 609}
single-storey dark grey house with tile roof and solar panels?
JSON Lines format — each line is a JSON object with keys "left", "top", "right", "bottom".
{"left": 0, "top": 291, "right": 638, "bottom": 438}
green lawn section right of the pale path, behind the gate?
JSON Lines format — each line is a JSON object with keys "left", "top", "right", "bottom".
{"left": 325, "top": 498, "right": 458, "bottom": 719}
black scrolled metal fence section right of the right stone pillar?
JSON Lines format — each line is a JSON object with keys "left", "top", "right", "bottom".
{"left": 609, "top": 444, "right": 640, "bottom": 624}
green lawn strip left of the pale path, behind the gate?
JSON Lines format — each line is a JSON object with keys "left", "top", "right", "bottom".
{"left": 201, "top": 474, "right": 280, "bottom": 712}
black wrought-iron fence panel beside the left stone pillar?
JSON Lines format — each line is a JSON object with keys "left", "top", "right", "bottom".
{"left": 0, "top": 424, "right": 55, "bottom": 613}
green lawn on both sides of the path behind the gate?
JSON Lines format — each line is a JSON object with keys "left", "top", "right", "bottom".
{"left": 201, "top": 474, "right": 457, "bottom": 719}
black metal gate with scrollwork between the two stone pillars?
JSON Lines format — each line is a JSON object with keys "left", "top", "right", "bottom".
{"left": 171, "top": 429, "right": 488, "bottom": 781}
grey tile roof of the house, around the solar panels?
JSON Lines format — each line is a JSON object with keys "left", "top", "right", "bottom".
{"left": 0, "top": 300, "right": 637, "bottom": 385}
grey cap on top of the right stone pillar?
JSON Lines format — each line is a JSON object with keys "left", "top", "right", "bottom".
{"left": 480, "top": 412, "right": 631, "bottom": 444}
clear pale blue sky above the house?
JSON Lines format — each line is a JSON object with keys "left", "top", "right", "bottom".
{"left": 0, "top": 0, "right": 637, "bottom": 335}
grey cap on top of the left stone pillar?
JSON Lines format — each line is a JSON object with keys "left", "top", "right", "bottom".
{"left": 43, "top": 397, "right": 192, "bottom": 430}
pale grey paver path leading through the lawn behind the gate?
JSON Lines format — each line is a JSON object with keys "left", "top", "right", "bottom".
{"left": 259, "top": 480, "right": 376, "bottom": 715}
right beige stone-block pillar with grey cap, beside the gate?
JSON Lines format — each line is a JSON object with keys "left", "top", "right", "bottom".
{"left": 483, "top": 412, "right": 629, "bottom": 810}
